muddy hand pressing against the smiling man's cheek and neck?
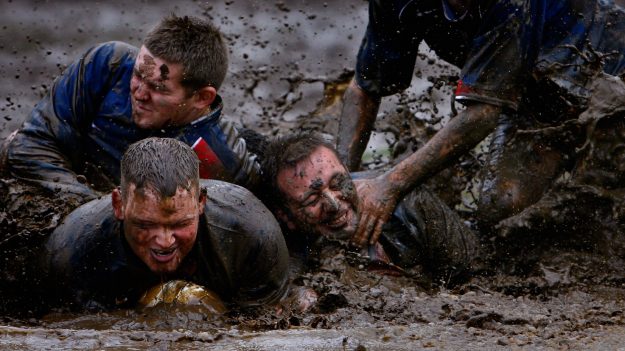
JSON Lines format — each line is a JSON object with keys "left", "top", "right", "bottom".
{"left": 352, "top": 177, "right": 397, "bottom": 247}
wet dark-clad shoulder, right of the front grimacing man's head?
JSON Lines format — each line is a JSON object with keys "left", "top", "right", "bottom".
{"left": 199, "top": 180, "right": 288, "bottom": 306}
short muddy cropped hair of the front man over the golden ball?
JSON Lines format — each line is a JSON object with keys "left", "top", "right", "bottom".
{"left": 121, "top": 138, "right": 200, "bottom": 202}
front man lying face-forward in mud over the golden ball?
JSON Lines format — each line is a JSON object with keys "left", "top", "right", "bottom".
{"left": 43, "top": 138, "right": 288, "bottom": 309}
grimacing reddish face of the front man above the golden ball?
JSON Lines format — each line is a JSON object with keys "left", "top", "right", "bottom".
{"left": 113, "top": 184, "right": 206, "bottom": 274}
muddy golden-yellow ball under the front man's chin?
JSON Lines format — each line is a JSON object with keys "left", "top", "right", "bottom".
{"left": 139, "top": 280, "right": 226, "bottom": 314}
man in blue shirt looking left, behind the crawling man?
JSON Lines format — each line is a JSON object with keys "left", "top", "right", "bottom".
{"left": 0, "top": 15, "right": 259, "bottom": 203}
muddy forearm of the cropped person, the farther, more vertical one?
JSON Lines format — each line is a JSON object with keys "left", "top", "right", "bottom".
{"left": 337, "top": 80, "right": 380, "bottom": 171}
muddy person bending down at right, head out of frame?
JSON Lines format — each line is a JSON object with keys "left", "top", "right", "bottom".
{"left": 337, "top": 0, "right": 625, "bottom": 245}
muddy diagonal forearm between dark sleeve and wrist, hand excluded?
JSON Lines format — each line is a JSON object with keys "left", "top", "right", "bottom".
{"left": 382, "top": 104, "right": 501, "bottom": 198}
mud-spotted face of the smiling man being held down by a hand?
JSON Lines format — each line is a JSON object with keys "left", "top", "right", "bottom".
{"left": 277, "top": 146, "right": 359, "bottom": 239}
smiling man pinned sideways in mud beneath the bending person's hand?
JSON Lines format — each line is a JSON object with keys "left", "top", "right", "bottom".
{"left": 262, "top": 133, "right": 479, "bottom": 281}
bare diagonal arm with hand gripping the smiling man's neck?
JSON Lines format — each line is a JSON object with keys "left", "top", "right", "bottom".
{"left": 352, "top": 103, "right": 501, "bottom": 246}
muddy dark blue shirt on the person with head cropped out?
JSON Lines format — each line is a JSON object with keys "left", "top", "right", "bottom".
{"left": 356, "top": 0, "right": 625, "bottom": 110}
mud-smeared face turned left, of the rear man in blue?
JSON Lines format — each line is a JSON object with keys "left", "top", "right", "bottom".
{"left": 130, "top": 46, "right": 204, "bottom": 129}
